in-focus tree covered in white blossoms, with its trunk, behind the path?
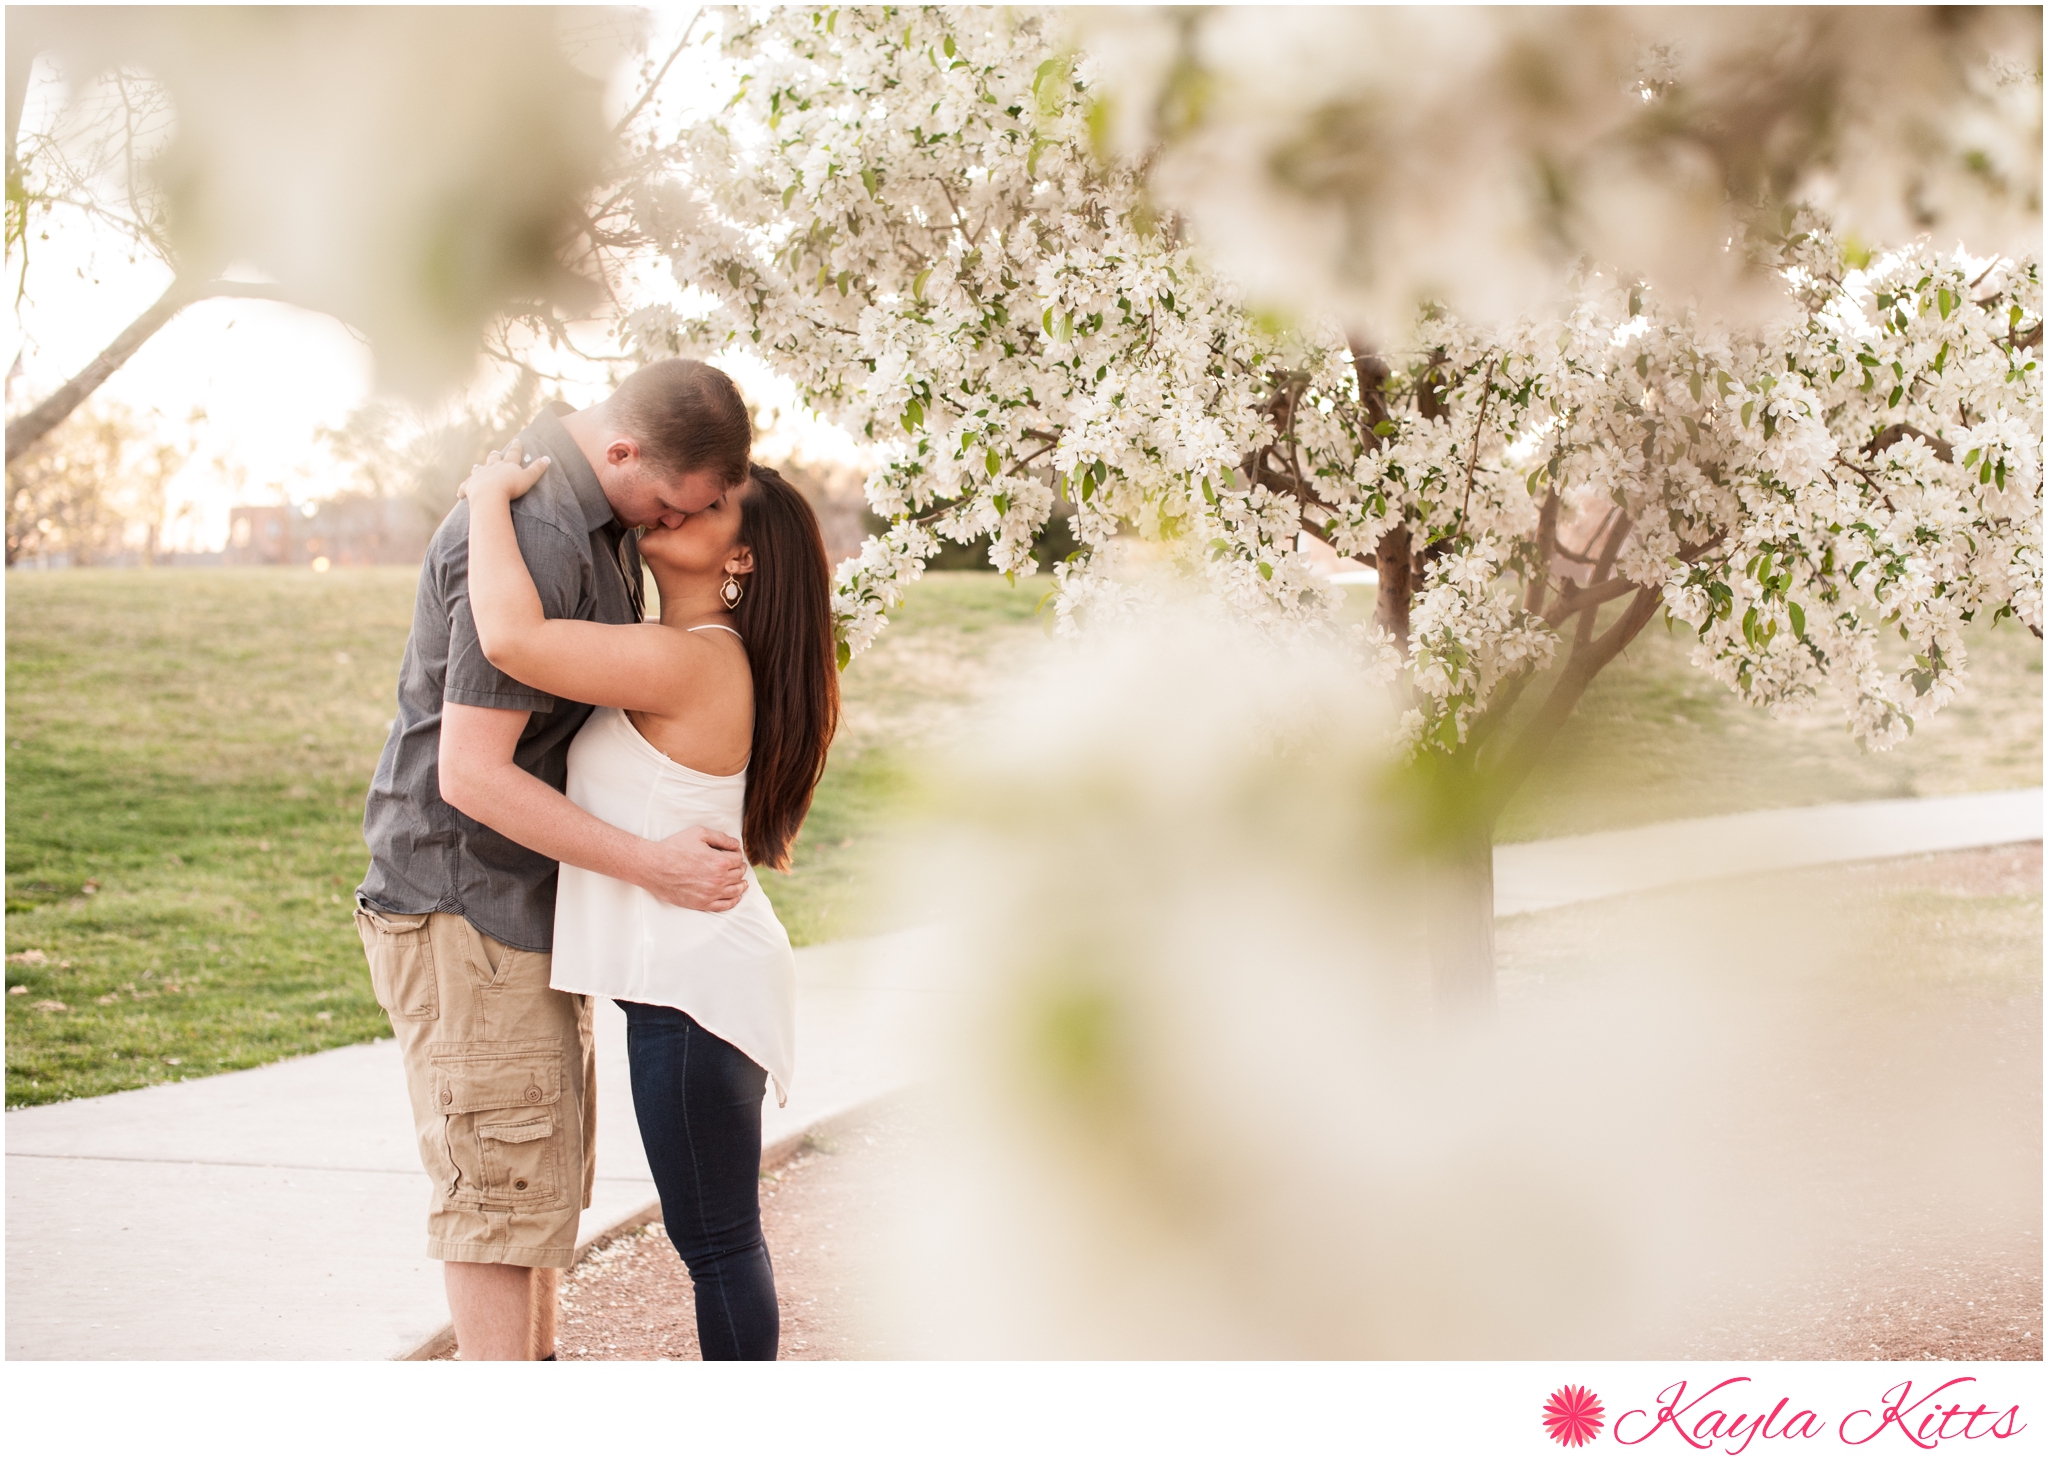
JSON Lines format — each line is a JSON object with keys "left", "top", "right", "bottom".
{"left": 627, "top": 8, "right": 2042, "bottom": 1005}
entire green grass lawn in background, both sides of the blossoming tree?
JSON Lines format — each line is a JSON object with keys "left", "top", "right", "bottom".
{"left": 6, "top": 569, "right": 2042, "bottom": 1106}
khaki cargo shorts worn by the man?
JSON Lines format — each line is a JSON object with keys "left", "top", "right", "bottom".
{"left": 356, "top": 907, "right": 598, "bottom": 1267}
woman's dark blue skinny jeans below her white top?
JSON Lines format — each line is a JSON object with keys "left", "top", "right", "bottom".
{"left": 618, "top": 1003, "right": 782, "bottom": 1360}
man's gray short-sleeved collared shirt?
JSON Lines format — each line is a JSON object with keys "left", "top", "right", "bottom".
{"left": 356, "top": 409, "right": 639, "bottom": 952}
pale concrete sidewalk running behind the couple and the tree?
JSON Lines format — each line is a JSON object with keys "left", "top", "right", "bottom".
{"left": 6, "top": 788, "right": 2042, "bottom": 1360}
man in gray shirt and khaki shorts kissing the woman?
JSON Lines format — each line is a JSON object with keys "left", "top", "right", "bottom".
{"left": 356, "top": 360, "right": 752, "bottom": 1360}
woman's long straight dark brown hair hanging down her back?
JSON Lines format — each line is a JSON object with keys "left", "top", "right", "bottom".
{"left": 733, "top": 465, "right": 840, "bottom": 870}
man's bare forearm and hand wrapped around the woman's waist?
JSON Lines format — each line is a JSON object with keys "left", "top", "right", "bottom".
{"left": 438, "top": 702, "right": 748, "bottom": 911}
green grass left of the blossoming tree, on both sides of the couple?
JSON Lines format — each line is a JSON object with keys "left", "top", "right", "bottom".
{"left": 6, "top": 569, "right": 1040, "bottom": 1106}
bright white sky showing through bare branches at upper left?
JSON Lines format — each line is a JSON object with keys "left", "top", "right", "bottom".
{"left": 6, "top": 27, "right": 856, "bottom": 551}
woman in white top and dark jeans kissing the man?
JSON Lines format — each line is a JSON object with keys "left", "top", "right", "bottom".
{"left": 463, "top": 452, "right": 840, "bottom": 1360}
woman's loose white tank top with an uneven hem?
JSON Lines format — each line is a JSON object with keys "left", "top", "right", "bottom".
{"left": 551, "top": 692, "right": 797, "bottom": 1104}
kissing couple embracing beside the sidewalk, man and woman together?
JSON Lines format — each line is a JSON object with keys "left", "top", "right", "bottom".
{"left": 356, "top": 360, "right": 840, "bottom": 1360}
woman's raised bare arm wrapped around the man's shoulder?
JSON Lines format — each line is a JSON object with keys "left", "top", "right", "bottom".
{"left": 463, "top": 450, "right": 705, "bottom": 713}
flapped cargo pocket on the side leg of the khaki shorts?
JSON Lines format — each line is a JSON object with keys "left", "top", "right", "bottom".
{"left": 428, "top": 1044, "right": 563, "bottom": 1210}
